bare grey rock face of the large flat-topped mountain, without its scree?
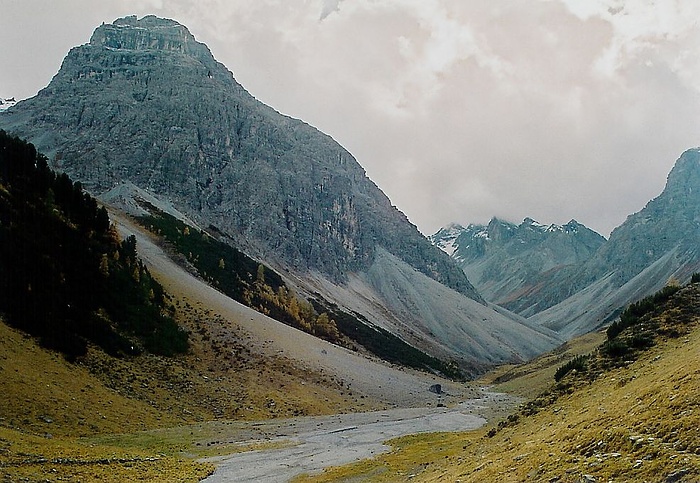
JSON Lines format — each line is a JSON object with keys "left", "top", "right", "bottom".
{"left": 0, "top": 16, "right": 480, "bottom": 300}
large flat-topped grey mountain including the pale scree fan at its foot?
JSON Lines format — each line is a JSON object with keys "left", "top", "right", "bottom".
{"left": 0, "top": 16, "right": 559, "bottom": 365}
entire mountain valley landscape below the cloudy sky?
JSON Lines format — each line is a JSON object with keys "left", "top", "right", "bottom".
{"left": 0, "top": 14, "right": 700, "bottom": 482}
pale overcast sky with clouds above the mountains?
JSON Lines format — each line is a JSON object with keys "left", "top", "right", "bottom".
{"left": 0, "top": 0, "right": 700, "bottom": 236}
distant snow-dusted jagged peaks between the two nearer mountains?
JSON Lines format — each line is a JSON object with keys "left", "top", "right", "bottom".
{"left": 431, "top": 218, "right": 605, "bottom": 315}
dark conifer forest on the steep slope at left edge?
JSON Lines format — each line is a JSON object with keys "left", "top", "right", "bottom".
{"left": 0, "top": 130, "right": 188, "bottom": 360}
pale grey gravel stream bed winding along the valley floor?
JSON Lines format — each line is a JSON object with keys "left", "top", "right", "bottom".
{"left": 200, "top": 388, "right": 518, "bottom": 483}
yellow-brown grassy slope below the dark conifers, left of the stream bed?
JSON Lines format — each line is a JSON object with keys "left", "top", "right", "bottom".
{"left": 0, "top": 284, "right": 374, "bottom": 481}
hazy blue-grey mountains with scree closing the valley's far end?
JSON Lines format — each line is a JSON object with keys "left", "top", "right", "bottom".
{"left": 430, "top": 148, "right": 700, "bottom": 337}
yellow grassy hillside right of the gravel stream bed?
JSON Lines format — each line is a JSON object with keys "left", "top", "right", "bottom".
{"left": 303, "top": 285, "right": 700, "bottom": 482}
